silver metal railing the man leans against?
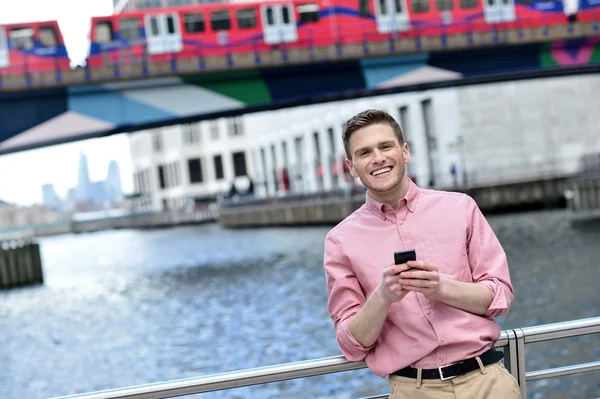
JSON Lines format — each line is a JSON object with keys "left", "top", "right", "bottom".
{"left": 54, "top": 317, "right": 600, "bottom": 399}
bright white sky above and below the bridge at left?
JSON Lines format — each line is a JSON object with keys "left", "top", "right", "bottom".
{"left": 0, "top": 0, "right": 133, "bottom": 206}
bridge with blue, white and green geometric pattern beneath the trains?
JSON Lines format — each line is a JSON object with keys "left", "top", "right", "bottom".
{"left": 0, "top": 19, "right": 600, "bottom": 154}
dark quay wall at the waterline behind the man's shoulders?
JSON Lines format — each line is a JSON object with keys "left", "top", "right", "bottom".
{"left": 219, "top": 176, "right": 571, "bottom": 228}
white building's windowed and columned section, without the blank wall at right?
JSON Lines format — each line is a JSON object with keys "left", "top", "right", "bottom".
{"left": 130, "top": 89, "right": 462, "bottom": 210}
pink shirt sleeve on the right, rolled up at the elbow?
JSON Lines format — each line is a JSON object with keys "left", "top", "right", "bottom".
{"left": 467, "top": 197, "right": 514, "bottom": 319}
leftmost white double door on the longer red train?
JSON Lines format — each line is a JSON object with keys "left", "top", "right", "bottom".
{"left": 145, "top": 13, "right": 183, "bottom": 55}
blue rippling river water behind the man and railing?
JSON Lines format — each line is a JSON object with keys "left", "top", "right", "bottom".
{"left": 0, "top": 211, "right": 600, "bottom": 399}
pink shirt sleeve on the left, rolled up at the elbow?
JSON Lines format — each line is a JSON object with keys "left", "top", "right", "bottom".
{"left": 324, "top": 232, "right": 375, "bottom": 362}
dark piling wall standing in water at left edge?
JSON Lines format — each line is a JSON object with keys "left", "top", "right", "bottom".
{"left": 0, "top": 241, "right": 44, "bottom": 289}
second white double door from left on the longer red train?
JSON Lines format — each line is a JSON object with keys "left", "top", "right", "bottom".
{"left": 260, "top": 4, "right": 298, "bottom": 44}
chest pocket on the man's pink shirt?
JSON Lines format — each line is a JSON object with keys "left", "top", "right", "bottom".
{"left": 425, "top": 236, "right": 469, "bottom": 276}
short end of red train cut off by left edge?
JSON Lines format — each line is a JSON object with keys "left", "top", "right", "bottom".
{"left": 0, "top": 21, "right": 70, "bottom": 76}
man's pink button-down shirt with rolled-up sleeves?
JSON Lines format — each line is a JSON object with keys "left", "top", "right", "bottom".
{"left": 324, "top": 182, "right": 513, "bottom": 377}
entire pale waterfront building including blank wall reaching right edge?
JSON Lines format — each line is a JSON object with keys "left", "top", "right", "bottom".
{"left": 131, "top": 75, "right": 600, "bottom": 214}
